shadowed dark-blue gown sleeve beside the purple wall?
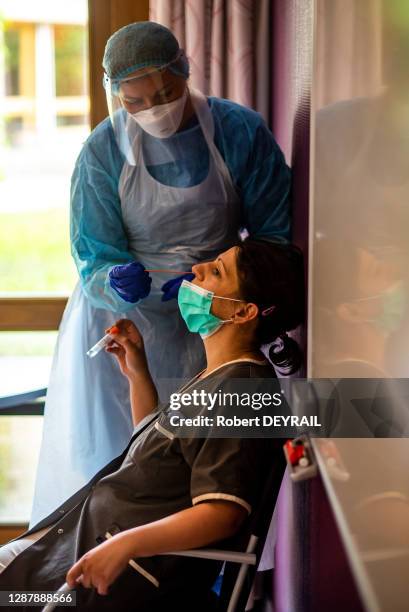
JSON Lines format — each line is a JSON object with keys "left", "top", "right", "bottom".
{"left": 211, "top": 98, "right": 291, "bottom": 242}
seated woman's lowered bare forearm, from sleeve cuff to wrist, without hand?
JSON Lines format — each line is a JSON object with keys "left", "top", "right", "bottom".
{"left": 121, "top": 501, "right": 246, "bottom": 557}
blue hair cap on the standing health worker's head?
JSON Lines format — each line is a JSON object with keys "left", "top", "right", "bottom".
{"left": 102, "top": 21, "right": 189, "bottom": 79}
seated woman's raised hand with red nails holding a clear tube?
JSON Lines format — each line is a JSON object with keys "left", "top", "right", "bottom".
{"left": 106, "top": 319, "right": 148, "bottom": 379}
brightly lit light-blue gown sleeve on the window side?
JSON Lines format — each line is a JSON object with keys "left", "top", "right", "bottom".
{"left": 70, "top": 119, "right": 134, "bottom": 312}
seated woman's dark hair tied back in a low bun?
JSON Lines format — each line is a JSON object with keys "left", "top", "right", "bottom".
{"left": 237, "top": 238, "right": 304, "bottom": 374}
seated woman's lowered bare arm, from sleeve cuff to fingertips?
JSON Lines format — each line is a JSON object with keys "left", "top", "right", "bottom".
{"left": 66, "top": 501, "right": 247, "bottom": 595}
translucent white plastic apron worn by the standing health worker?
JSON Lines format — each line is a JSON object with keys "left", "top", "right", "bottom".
{"left": 30, "top": 90, "right": 239, "bottom": 525}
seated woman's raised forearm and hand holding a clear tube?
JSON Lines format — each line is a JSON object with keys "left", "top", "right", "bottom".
{"left": 106, "top": 319, "right": 158, "bottom": 425}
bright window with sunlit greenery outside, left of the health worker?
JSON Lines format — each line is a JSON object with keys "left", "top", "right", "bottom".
{"left": 0, "top": 0, "right": 90, "bottom": 523}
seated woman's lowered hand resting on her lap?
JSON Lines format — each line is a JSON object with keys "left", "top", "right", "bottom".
{"left": 66, "top": 531, "right": 132, "bottom": 595}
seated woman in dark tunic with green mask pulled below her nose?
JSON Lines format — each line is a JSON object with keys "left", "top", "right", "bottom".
{"left": 0, "top": 240, "right": 304, "bottom": 612}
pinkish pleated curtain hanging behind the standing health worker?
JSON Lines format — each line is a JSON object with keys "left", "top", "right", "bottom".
{"left": 150, "top": 0, "right": 272, "bottom": 123}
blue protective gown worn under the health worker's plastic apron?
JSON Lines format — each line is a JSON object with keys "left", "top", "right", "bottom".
{"left": 71, "top": 97, "right": 290, "bottom": 312}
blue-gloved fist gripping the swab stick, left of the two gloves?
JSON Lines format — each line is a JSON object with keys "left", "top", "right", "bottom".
{"left": 109, "top": 261, "right": 152, "bottom": 302}
